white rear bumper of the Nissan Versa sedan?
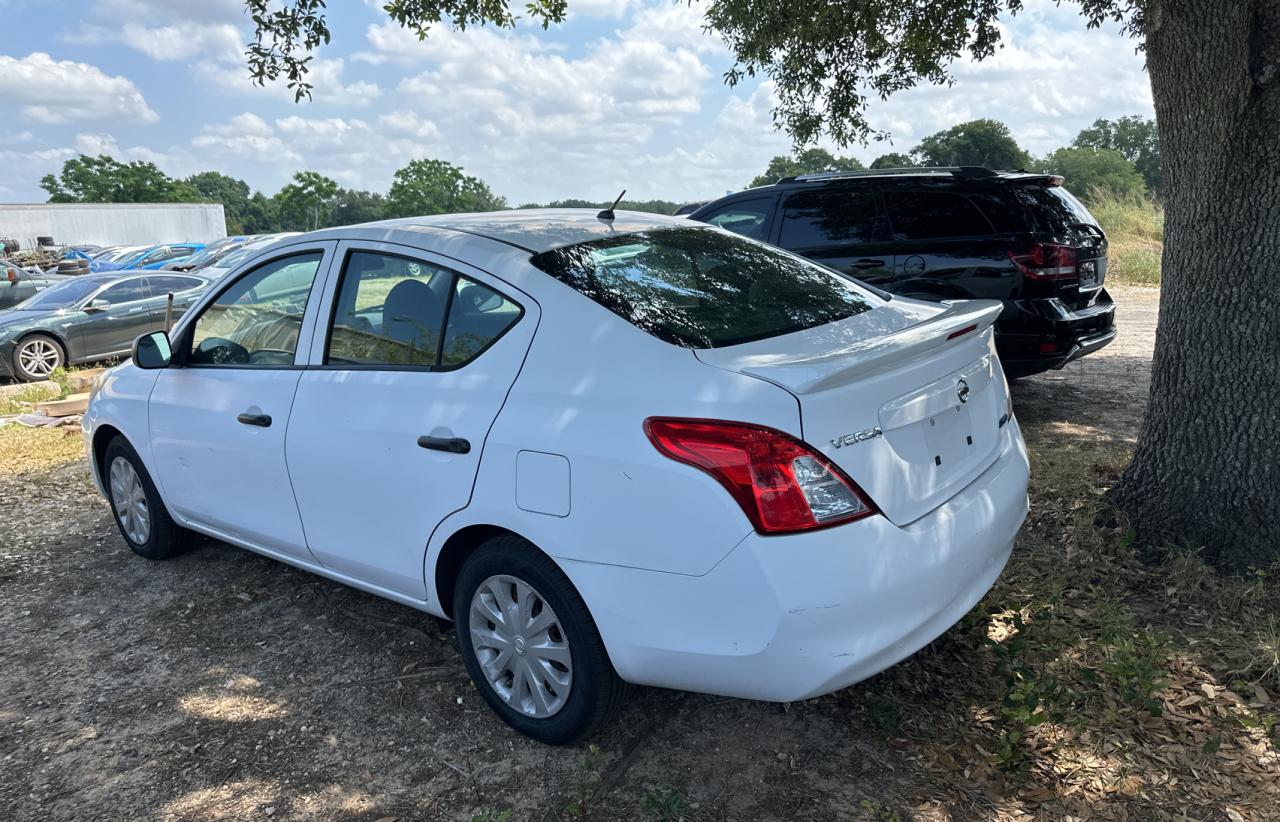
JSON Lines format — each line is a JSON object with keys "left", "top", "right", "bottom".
{"left": 564, "top": 421, "right": 1028, "bottom": 702}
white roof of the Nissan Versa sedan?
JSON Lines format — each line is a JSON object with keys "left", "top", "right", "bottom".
{"left": 325, "top": 209, "right": 694, "bottom": 254}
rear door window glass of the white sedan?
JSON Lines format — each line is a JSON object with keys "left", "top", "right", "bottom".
{"left": 325, "top": 251, "right": 521, "bottom": 369}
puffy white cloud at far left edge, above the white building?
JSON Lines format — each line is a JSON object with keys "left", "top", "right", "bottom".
{"left": 0, "top": 51, "right": 159, "bottom": 124}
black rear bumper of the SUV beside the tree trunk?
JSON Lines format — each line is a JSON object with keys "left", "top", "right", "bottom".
{"left": 996, "top": 289, "right": 1116, "bottom": 376}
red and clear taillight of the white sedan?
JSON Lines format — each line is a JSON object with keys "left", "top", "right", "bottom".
{"left": 644, "top": 417, "right": 876, "bottom": 534}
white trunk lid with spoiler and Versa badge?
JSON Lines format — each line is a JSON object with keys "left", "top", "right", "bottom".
{"left": 695, "top": 298, "right": 1006, "bottom": 525}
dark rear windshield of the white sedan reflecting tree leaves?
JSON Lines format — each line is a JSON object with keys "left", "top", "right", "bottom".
{"left": 531, "top": 228, "right": 877, "bottom": 348}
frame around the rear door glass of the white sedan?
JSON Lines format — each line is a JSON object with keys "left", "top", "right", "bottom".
{"left": 307, "top": 239, "right": 538, "bottom": 374}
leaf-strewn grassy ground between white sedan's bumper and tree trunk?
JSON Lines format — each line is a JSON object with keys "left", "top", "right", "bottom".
{"left": 838, "top": 428, "right": 1280, "bottom": 818}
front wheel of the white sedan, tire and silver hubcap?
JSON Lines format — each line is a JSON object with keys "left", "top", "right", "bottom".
{"left": 102, "top": 437, "right": 191, "bottom": 560}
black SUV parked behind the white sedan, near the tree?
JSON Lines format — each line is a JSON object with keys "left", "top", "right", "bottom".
{"left": 689, "top": 166, "right": 1116, "bottom": 376}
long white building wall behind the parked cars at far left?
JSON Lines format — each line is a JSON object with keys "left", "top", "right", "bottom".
{"left": 0, "top": 202, "right": 227, "bottom": 248}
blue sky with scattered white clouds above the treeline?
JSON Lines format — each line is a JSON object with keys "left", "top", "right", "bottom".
{"left": 0, "top": 0, "right": 1152, "bottom": 205}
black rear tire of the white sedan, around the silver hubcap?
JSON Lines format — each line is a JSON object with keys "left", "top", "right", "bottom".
{"left": 453, "top": 535, "right": 626, "bottom": 745}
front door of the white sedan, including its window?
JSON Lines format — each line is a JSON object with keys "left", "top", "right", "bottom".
{"left": 150, "top": 242, "right": 337, "bottom": 562}
